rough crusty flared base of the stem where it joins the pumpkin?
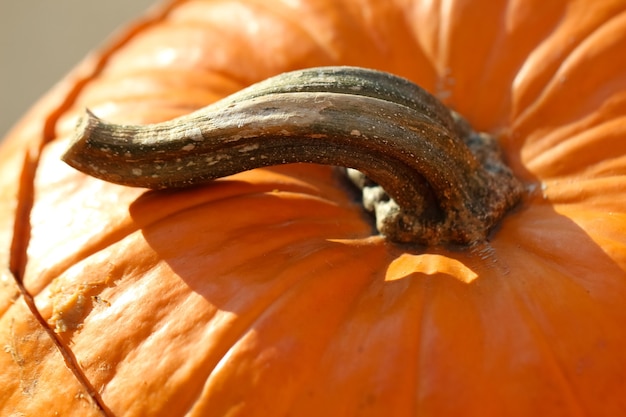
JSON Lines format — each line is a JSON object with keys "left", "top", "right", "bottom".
{"left": 344, "top": 112, "right": 524, "bottom": 246}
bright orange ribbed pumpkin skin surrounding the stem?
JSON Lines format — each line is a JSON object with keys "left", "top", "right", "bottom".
{"left": 0, "top": 0, "right": 626, "bottom": 416}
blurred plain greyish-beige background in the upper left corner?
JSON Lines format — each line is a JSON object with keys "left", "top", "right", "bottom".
{"left": 0, "top": 0, "right": 157, "bottom": 140}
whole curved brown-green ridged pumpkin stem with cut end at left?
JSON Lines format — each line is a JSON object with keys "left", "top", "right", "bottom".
{"left": 63, "top": 67, "right": 522, "bottom": 245}
